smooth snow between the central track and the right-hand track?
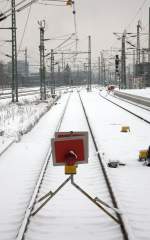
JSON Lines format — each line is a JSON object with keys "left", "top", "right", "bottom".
{"left": 82, "top": 92, "right": 150, "bottom": 240}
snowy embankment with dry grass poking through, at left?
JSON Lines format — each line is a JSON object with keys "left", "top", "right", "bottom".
{"left": 0, "top": 96, "right": 60, "bottom": 155}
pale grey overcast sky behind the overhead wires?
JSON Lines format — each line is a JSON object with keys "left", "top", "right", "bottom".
{"left": 0, "top": 0, "right": 150, "bottom": 69}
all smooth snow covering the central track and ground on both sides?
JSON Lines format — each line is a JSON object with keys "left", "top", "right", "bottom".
{"left": 0, "top": 87, "right": 150, "bottom": 240}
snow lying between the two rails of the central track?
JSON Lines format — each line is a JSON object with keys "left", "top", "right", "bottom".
{"left": 25, "top": 93, "right": 122, "bottom": 240}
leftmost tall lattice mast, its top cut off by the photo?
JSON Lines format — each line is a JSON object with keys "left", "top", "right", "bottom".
{"left": 11, "top": 0, "right": 18, "bottom": 102}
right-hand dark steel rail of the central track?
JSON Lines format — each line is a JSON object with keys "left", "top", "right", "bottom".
{"left": 78, "top": 92, "right": 129, "bottom": 240}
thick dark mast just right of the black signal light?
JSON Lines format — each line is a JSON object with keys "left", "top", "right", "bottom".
{"left": 121, "top": 31, "right": 126, "bottom": 89}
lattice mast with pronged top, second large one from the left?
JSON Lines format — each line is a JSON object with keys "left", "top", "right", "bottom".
{"left": 38, "top": 20, "right": 46, "bottom": 100}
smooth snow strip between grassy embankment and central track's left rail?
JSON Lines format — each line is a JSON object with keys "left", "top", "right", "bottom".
{"left": 0, "top": 95, "right": 67, "bottom": 240}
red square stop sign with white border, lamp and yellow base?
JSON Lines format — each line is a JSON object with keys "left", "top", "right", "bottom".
{"left": 51, "top": 132, "right": 88, "bottom": 174}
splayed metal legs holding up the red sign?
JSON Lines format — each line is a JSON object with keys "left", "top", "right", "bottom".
{"left": 31, "top": 175, "right": 121, "bottom": 224}
